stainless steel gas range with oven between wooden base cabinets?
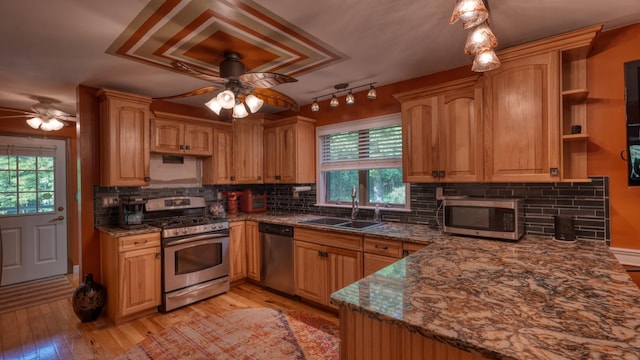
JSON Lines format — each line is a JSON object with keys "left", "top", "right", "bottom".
{"left": 144, "top": 197, "right": 230, "bottom": 312}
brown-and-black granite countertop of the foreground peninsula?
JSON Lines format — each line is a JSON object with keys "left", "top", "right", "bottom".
{"left": 331, "top": 236, "right": 640, "bottom": 359}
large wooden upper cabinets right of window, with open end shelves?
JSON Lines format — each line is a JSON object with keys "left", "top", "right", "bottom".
{"left": 395, "top": 25, "right": 602, "bottom": 182}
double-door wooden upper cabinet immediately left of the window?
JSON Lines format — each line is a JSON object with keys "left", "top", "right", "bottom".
{"left": 264, "top": 116, "right": 315, "bottom": 184}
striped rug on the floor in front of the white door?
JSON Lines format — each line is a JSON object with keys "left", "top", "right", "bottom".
{"left": 0, "top": 275, "right": 74, "bottom": 314}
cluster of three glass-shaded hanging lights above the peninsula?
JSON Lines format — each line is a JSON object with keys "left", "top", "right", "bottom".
{"left": 450, "top": 0, "right": 500, "bottom": 72}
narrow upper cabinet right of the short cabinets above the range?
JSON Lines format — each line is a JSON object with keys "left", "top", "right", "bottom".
{"left": 202, "top": 123, "right": 234, "bottom": 185}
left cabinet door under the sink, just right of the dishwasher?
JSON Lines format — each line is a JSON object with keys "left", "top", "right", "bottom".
{"left": 293, "top": 241, "right": 328, "bottom": 304}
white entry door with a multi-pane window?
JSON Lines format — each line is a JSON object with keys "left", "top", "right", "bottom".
{"left": 0, "top": 136, "right": 67, "bottom": 285}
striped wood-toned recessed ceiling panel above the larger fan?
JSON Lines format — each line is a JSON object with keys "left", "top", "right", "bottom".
{"left": 107, "top": 0, "right": 346, "bottom": 76}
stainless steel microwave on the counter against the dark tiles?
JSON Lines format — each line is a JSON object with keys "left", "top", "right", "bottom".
{"left": 442, "top": 198, "right": 524, "bottom": 240}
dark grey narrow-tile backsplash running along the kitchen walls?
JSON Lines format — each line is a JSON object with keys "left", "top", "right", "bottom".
{"left": 94, "top": 176, "right": 610, "bottom": 243}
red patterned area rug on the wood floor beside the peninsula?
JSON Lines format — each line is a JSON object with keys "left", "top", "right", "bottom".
{"left": 117, "top": 308, "right": 339, "bottom": 360}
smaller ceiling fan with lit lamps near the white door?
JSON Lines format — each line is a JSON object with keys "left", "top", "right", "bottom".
{"left": 0, "top": 96, "right": 76, "bottom": 131}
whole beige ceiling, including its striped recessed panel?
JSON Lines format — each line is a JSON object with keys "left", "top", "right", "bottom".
{"left": 0, "top": 0, "right": 640, "bottom": 116}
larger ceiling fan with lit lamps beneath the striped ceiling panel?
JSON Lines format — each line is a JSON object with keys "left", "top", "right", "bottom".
{"left": 154, "top": 51, "right": 300, "bottom": 118}
